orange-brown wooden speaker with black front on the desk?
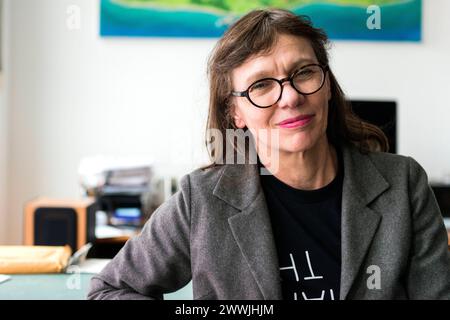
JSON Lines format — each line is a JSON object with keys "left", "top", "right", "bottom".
{"left": 24, "top": 198, "right": 97, "bottom": 252}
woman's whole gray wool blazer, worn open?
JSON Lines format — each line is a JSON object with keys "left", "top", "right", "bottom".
{"left": 88, "top": 147, "right": 450, "bottom": 299}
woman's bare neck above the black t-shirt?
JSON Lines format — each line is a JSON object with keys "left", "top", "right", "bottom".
{"left": 260, "top": 139, "right": 338, "bottom": 190}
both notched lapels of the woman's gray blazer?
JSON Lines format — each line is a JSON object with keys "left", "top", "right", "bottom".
{"left": 213, "top": 145, "right": 389, "bottom": 300}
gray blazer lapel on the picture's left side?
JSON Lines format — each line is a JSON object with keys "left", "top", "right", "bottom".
{"left": 213, "top": 165, "right": 282, "bottom": 300}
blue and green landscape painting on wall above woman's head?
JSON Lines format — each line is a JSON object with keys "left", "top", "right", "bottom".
{"left": 100, "top": 0, "right": 422, "bottom": 41}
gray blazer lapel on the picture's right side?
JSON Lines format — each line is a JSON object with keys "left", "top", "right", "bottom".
{"left": 340, "top": 146, "right": 389, "bottom": 300}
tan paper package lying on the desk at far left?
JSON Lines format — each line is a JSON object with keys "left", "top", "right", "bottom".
{"left": 0, "top": 246, "right": 72, "bottom": 274}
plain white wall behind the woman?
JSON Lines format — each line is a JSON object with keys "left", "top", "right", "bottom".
{"left": 0, "top": 0, "right": 450, "bottom": 243}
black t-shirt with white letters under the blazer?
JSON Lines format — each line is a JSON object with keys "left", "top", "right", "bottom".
{"left": 258, "top": 148, "right": 344, "bottom": 300}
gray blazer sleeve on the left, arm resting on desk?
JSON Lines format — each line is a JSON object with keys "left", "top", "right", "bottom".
{"left": 87, "top": 175, "right": 191, "bottom": 300}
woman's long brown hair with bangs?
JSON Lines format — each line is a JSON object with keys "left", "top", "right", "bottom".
{"left": 205, "top": 9, "right": 389, "bottom": 168}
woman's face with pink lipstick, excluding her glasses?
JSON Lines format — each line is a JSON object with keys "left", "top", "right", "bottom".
{"left": 231, "top": 35, "right": 331, "bottom": 153}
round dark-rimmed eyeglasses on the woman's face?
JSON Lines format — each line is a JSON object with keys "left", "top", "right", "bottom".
{"left": 231, "top": 64, "right": 328, "bottom": 108}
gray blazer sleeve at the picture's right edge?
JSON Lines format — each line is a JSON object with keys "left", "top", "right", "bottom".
{"left": 406, "top": 158, "right": 450, "bottom": 299}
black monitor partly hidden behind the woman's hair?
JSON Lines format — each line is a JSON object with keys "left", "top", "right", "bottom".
{"left": 350, "top": 100, "right": 397, "bottom": 153}
